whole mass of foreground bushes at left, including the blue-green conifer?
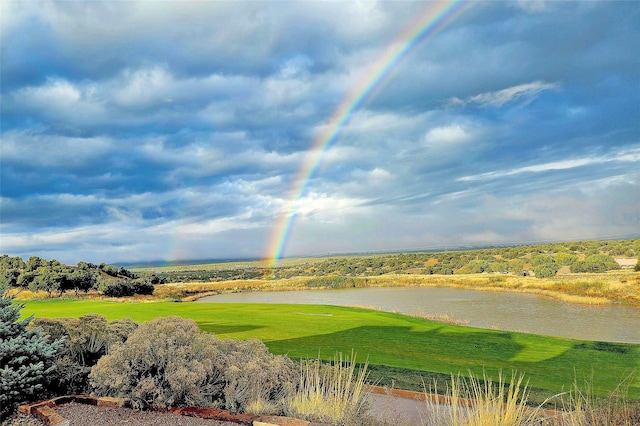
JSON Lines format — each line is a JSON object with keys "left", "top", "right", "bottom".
{"left": 0, "top": 306, "right": 299, "bottom": 419}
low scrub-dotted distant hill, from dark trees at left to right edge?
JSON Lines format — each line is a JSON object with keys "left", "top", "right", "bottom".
{"left": 130, "top": 239, "right": 640, "bottom": 282}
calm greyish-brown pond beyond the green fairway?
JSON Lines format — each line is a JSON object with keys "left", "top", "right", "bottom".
{"left": 199, "top": 287, "right": 640, "bottom": 343}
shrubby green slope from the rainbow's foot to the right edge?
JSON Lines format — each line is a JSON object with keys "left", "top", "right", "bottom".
{"left": 275, "top": 240, "right": 640, "bottom": 278}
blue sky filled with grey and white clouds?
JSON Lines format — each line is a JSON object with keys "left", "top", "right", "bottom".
{"left": 0, "top": 1, "right": 640, "bottom": 264}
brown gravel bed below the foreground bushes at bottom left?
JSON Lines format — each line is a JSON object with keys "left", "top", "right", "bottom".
{"left": 56, "top": 402, "right": 238, "bottom": 426}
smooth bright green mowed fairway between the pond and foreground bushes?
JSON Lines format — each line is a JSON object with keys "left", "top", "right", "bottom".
{"left": 22, "top": 299, "right": 640, "bottom": 399}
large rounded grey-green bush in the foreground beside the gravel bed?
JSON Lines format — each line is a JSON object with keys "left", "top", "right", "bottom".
{"left": 89, "top": 317, "right": 296, "bottom": 414}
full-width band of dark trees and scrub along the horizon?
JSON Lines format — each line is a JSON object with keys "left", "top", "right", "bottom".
{"left": 0, "top": 240, "right": 640, "bottom": 297}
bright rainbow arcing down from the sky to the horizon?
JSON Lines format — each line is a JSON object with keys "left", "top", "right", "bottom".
{"left": 265, "top": 0, "right": 471, "bottom": 266}
